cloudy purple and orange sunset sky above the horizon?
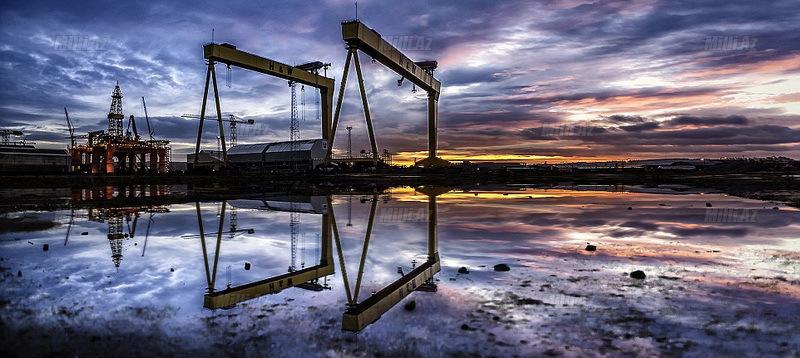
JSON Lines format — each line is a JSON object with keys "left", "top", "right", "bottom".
{"left": 0, "top": 0, "right": 800, "bottom": 162}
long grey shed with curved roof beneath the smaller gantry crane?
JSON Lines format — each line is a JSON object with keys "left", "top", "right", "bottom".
{"left": 186, "top": 139, "right": 328, "bottom": 172}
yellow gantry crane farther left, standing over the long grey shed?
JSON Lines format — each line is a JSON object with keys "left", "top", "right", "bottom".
{"left": 194, "top": 43, "right": 334, "bottom": 166}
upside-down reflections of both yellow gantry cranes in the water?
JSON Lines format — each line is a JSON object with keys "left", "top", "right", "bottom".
{"left": 192, "top": 187, "right": 449, "bottom": 331}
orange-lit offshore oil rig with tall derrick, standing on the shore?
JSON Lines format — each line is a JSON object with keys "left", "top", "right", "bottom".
{"left": 64, "top": 83, "right": 171, "bottom": 174}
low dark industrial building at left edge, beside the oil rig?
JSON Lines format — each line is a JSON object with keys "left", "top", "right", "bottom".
{"left": 0, "top": 129, "right": 70, "bottom": 174}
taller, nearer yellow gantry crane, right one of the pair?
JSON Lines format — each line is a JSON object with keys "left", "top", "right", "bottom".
{"left": 326, "top": 20, "right": 450, "bottom": 167}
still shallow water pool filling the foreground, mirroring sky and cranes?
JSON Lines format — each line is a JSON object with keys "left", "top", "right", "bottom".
{"left": 0, "top": 185, "right": 800, "bottom": 357}
